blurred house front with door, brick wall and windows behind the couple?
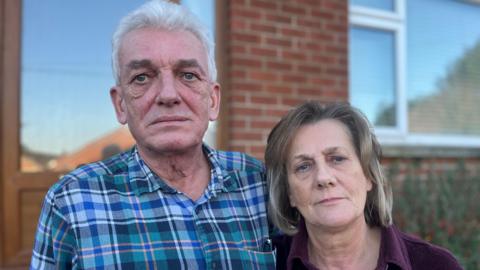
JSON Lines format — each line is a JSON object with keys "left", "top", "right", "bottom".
{"left": 0, "top": 0, "right": 480, "bottom": 269}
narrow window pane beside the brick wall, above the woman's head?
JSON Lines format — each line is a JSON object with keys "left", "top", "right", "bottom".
{"left": 349, "top": 27, "right": 396, "bottom": 127}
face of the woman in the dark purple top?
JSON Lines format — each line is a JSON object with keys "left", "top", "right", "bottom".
{"left": 287, "top": 119, "right": 372, "bottom": 230}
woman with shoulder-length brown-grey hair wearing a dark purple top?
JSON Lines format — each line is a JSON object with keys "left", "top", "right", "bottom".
{"left": 265, "top": 102, "right": 462, "bottom": 269}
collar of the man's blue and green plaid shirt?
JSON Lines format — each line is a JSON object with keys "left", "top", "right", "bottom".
{"left": 127, "top": 144, "right": 238, "bottom": 197}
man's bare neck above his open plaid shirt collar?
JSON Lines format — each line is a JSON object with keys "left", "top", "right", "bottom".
{"left": 139, "top": 145, "right": 210, "bottom": 201}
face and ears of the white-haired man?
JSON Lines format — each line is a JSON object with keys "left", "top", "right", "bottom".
{"left": 110, "top": 28, "right": 220, "bottom": 153}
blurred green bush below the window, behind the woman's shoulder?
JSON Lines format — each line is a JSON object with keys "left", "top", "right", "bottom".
{"left": 389, "top": 163, "right": 480, "bottom": 269}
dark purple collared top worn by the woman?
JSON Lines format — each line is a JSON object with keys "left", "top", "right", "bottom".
{"left": 273, "top": 222, "right": 462, "bottom": 270}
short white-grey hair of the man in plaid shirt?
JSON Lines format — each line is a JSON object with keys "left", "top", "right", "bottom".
{"left": 112, "top": 0, "right": 217, "bottom": 84}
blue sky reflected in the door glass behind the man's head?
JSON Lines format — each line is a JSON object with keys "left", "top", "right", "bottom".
{"left": 21, "top": 0, "right": 214, "bottom": 154}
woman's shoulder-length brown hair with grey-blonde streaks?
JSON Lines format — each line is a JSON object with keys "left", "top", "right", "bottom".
{"left": 265, "top": 101, "right": 392, "bottom": 235}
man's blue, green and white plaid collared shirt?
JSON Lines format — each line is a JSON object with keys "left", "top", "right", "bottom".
{"left": 30, "top": 146, "right": 275, "bottom": 269}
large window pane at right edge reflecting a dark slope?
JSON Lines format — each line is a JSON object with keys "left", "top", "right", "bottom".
{"left": 407, "top": 0, "right": 480, "bottom": 135}
